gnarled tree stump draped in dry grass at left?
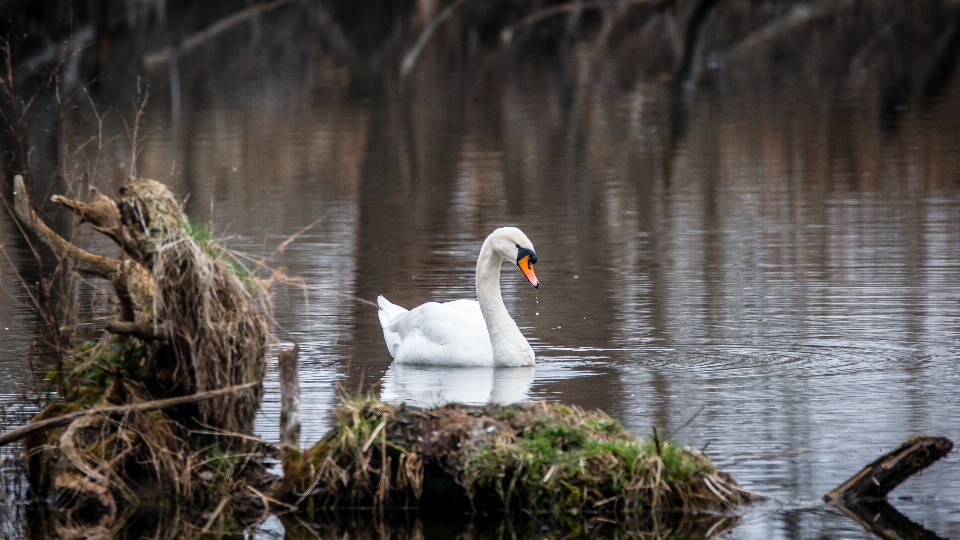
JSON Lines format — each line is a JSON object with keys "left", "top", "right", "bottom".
{"left": 14, "top": 176, "right": 272, "bottom": 512}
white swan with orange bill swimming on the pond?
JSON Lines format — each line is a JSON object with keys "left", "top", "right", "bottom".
{"left": 377, "top": 227, "right": 540, "bottom": 367}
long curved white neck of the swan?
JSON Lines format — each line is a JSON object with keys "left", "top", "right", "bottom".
{"left": 477, "top": 242, "right": 533, "bottom": 366}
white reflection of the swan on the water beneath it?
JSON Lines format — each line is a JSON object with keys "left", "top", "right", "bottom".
{"left": 380, "top": 362, "right": 534, "bottom": 407}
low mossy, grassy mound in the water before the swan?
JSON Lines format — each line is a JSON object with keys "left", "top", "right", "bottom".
{"left": 276, "top": 397, "right": 755, "bottom": 516}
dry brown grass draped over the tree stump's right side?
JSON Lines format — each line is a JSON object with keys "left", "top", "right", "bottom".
{"left": 121, "top": 179, "right": 273, "bottom": 432}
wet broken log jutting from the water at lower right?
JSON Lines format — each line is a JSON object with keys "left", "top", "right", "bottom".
{"left": 824, "top": 436, "right": 953, "bottom": 505}
